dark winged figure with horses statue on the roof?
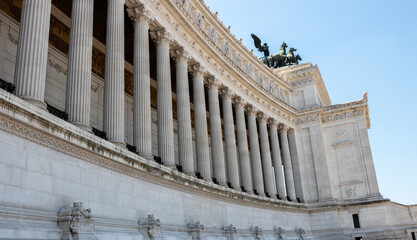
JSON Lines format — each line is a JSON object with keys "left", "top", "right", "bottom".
{"left": 251, "top": 33, "right": 302, "bottom": 68}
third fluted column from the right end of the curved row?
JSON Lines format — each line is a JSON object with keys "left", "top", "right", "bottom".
{"left": 258, "top": 113, "right": 277, "bottom": 198}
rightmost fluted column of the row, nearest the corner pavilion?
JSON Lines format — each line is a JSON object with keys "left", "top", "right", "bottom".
{"left": 279, "top": 125, "right": 297, "bottom": 201}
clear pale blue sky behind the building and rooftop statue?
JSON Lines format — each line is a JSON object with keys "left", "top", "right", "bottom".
{"left": 205, "top": 0, "right": 417, "bottom": 204}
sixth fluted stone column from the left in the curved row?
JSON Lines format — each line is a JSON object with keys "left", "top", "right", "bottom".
{"left": 174, "top": 48, "right": 194, "bottom": 175}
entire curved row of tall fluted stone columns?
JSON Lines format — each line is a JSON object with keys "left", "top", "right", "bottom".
{"left": 15, "top": 0, "right": 297, "bottom": 201}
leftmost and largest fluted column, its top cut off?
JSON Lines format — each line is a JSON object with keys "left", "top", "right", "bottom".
{"left": 14, "top": 0, "right": 51, "bottom": 109}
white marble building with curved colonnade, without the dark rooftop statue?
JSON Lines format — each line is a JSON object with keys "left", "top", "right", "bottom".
{"left": 0, "top": 0, "right": 417, "bottom": 240}
